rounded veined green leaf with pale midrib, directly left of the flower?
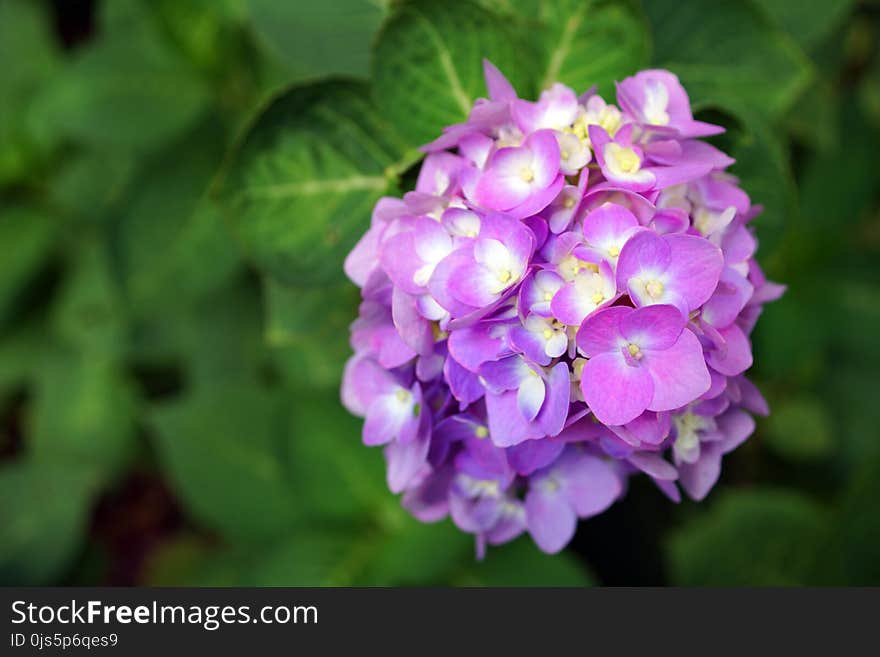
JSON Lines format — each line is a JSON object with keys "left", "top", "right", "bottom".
{"left": 220, "top": 80, "right": 414, "bottom": 287}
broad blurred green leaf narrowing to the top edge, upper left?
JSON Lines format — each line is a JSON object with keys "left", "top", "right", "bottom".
{"left": 29, "top": 0, "right": 208, "bottom": 151}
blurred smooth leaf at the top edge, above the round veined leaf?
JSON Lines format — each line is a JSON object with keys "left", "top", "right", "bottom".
{"left": 246, "top": 0, "right": 386, "bottom": 77}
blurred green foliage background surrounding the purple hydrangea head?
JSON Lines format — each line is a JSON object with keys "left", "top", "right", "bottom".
{"left": 0, "top": 0, "right": 880, "bottom": 585}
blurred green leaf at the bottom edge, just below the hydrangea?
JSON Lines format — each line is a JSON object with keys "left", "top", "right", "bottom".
{"left": 454, "top": 537, "right": 595, "bottom": 586}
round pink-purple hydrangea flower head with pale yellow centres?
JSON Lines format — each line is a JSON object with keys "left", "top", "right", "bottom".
{"left": 342, "top": 62, "right": 783, "bottom": 555}
